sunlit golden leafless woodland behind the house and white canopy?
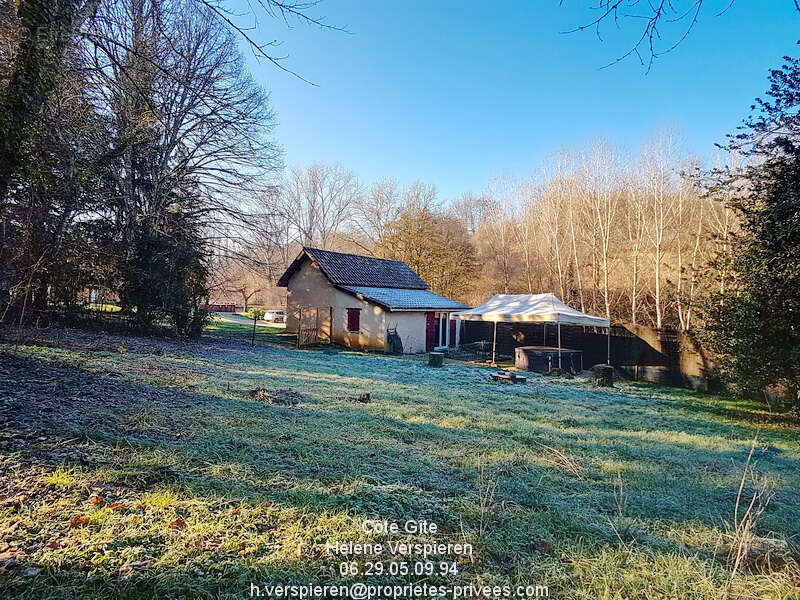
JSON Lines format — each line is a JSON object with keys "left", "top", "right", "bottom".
{"left": 225, "top": 132, "right": 737, "bottom": 330}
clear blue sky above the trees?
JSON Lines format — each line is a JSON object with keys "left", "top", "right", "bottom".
{"left": 234, "top": 0, "right": 800, "bottom": 200}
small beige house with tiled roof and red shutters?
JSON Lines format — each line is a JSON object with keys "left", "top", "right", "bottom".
{"left": 278, "top": 248, "right": 469, "bottom": 354}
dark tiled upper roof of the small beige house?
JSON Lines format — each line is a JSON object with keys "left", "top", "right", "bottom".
{"left": 278, "top": 248, "right": 428, "bottom": 290}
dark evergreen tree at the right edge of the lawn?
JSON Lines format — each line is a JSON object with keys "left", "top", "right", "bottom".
{"left": 706, "top": 57, "right": 800, "bottom": 405}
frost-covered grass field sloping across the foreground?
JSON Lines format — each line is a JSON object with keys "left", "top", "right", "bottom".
{"left": 0, "top": 323, "right": 800, "bottom": 600}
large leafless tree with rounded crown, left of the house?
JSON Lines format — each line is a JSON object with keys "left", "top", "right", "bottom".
{"left": 91, "top": 0, "right": 280, "bottom": 232}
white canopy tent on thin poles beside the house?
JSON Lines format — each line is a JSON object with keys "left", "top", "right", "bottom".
{"left": 453, "top": 294, "right": 611, "bottom": 368}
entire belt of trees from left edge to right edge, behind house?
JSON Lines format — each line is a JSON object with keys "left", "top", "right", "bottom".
{"left": 0, "top": 0, "right": 800, "bottom": 403}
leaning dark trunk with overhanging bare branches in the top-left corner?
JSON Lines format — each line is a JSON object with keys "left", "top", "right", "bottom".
{"left": 0, "top": 0, "right": 332, "bottom": 209}
